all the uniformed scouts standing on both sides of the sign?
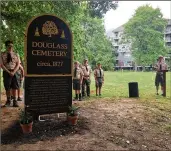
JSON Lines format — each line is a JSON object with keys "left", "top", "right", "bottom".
{"left": 0, "top": 40, "right": 167, "bottom": 107}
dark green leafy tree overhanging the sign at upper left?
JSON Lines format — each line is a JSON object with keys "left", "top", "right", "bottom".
{"left": 1, "top": 1, "right": 79, "bottom": 57}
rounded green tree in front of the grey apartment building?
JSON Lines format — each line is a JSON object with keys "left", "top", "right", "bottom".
{"left": 124, "top": 5, "right": 167, "bottom": 65}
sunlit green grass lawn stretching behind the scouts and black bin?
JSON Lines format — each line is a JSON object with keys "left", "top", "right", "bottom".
{"left": 1, "top": 71, "right": 171, "bottom": 130}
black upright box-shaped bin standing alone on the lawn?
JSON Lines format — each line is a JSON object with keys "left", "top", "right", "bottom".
{"left": 129, "top": 82, "right": 139, "bottom": 98}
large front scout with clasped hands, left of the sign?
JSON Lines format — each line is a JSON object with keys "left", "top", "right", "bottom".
{"left": 0, "top": 40, "right": 20, "bottom": 107}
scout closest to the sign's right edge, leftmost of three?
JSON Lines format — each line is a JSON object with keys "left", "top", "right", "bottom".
{"left": 73, "top": 61, "right": 83, "bottom": 101}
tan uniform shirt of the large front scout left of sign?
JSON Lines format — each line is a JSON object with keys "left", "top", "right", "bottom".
{"left": 1, "top": 51, "right": 20, "bottom": 70}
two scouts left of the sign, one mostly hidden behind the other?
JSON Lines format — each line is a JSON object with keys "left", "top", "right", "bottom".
{"left": 0, "top": 40, "right": 24, "bottom": 107}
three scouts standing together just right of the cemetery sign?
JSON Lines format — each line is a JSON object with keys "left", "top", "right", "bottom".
{"left": 73, "top": 59, "right": 104, "bottom": 101}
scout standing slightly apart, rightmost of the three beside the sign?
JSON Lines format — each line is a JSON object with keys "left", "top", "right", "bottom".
{"left": 94, "top": 63, "right": 104, "bottom": 96}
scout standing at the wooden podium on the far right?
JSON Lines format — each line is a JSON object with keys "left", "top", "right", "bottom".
{"left": 154, "top": 55, "right": 167, "bottom": 95}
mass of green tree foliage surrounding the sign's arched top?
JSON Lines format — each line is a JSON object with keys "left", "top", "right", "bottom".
{"left": 1, "top": 0, "right": 118, "bottom": 70}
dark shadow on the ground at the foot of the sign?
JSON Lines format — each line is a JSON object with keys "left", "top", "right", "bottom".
{"left": 1, "top": 114, "right": 89, "bottom": 145}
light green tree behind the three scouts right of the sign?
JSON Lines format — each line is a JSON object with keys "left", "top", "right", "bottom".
{"left": 77, "top": 10, "right": 114, "bottom": 70}
